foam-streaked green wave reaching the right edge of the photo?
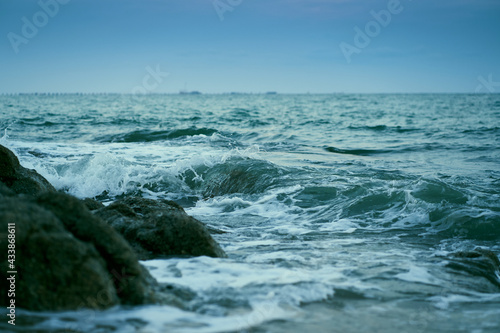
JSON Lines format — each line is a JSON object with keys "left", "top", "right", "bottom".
{"left": 292, "top": 175, "right": 500, "bottom": 237}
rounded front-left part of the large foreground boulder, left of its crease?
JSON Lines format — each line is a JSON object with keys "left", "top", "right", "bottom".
{"left": 0, "top": 193, "right": 119, "bottom": 311}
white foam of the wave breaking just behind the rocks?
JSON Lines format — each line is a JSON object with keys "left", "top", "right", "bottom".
{"left": 0, "top": 135, "right": 270, "bottom": 198}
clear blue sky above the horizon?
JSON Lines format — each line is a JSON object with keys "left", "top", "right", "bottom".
{"left": 0, "top": 0, "right": 500, "bottom": 94}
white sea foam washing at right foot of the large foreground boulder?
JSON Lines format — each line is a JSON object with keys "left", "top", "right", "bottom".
{"left": 125, "top": 256, "right": 340, "bottom": 332}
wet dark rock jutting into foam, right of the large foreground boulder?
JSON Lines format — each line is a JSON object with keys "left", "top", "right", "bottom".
{"left": 95, "top": 197, "right": 226, "bottom": 260}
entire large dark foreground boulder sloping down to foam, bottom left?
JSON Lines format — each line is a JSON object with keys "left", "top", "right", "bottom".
{"left": 0, "top": 191, "right": 163, "bottom": 311}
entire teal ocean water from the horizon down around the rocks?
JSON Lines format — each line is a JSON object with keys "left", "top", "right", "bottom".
{"left": 0, "top": 94, "right": 500, "bottom": 333}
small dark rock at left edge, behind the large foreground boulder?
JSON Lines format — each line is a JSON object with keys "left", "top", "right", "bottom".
{"left": 0, "top": 145, "right": 56, "bottom": 196}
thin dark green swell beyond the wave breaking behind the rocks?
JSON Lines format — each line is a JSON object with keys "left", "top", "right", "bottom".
{"left": 97, "top": 127, "right": 218, "bottom": 143}
